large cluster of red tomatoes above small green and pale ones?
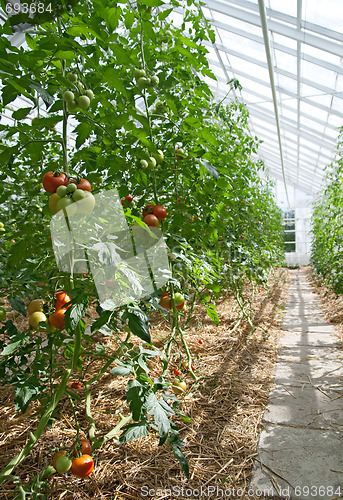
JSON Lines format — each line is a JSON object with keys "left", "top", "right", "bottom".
{"left": 42, "top": 171, "right": 95, "bottom": 216}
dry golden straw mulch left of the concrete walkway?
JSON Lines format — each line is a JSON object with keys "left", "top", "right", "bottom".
{"left": 0, "top": 269, "right": 289, "bottom": 500}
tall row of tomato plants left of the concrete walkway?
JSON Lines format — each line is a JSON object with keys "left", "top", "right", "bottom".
{"left": 0, "top": 0, "right": 283, "bottom": 497}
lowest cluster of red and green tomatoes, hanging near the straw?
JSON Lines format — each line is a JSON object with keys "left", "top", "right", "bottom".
{"left": 52, "top": 438, "right": 94, "bottom": 479}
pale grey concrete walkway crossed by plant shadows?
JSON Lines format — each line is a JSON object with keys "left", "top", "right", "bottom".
{"left": 251, "top": 269, "right": 343, "bottom": 500}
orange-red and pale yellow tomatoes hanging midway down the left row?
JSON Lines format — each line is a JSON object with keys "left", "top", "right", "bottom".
{"left": 27, "top": 290, "right": 71, "bottom": 330}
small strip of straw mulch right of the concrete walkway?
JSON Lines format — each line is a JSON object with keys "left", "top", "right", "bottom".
{"left": 307, "top": 267, "right": 343, "bottom": 343}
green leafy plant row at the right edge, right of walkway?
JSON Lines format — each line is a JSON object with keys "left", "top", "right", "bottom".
{"left": 311, "top": 127, "right": 343, "bottom": 294}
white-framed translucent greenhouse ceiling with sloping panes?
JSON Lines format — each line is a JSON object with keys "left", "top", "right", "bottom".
{"left": 3, "top": 0, "right": 343, "bottom": 194}
